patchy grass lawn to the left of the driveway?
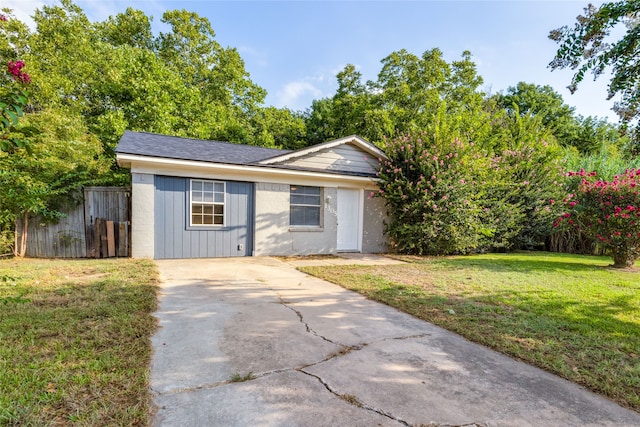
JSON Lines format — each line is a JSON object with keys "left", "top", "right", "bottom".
{"left": 0, "top": 259, "right": 158, "bottom": 426}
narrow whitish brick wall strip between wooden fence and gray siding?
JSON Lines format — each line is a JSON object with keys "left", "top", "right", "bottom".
{"left": 131, "top": 173, "right": 155, "bottom": 258}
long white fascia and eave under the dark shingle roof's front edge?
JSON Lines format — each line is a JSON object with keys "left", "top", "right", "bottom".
{"left": 117, "top": 154, "right": 376, "bottom": 188}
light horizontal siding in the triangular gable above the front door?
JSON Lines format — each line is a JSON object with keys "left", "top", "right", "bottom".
{"left": 281, "top": 144, "right": 378, "bottom": 173}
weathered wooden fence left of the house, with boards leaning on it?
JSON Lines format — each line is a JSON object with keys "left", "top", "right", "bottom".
{"left": 20, "top": 187, "right": 131, "bottom": 258}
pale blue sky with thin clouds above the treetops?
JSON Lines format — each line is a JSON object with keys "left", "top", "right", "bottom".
{"left": 0, "top": 0, "right": 617, "bottom": 121}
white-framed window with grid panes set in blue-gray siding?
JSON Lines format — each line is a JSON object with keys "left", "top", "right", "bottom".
{"left": 189, "top": 179, "right": 225, "bottom": 227}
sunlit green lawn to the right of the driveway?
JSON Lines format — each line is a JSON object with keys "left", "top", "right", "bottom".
{"left": 301, "top": 252, "right": 640, "bottom": 411}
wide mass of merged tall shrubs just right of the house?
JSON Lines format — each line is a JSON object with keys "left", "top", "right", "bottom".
{"left": 377, "top": 113, "right": 563, "bottom": 255}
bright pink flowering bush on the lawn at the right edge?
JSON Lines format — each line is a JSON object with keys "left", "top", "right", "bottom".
{"left": 553, "top": 169, "right": 640, "bottom": 268}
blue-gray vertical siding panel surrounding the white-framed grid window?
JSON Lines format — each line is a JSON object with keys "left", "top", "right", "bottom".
{"left": 155, "top": 176, "right": 254, "bottom": 259}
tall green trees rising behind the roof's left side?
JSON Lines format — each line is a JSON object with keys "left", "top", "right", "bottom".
{"left": 13, "top": 0, "right": 306, "bottom": 172}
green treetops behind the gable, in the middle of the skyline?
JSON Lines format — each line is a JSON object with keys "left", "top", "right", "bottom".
{"left": 306, "top": 49, "right": 490, "bottom": 144}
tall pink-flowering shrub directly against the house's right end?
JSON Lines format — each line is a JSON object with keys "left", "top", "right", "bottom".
{"left": 377, "top": 133, "right": 479, "bottom": 255}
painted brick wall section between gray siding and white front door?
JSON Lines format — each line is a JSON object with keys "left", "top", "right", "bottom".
{"left": 254, "top": 182, "right": 338, "bottom": 256}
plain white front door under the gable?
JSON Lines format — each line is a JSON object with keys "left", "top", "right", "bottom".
{"left": 336, "top": 188, "right": 362, "bottom": 252}
